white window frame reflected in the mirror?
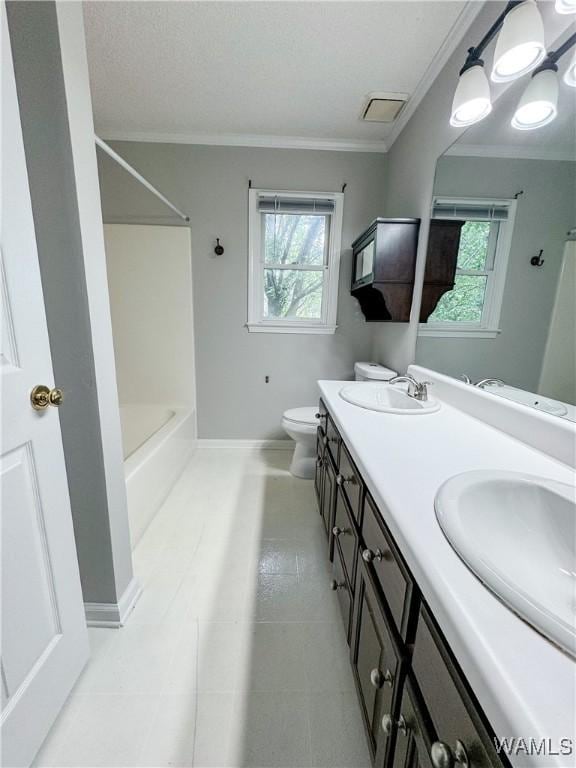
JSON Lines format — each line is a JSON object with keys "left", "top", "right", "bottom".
{"left": 418, "top": 196, "right": 517, "bottom": 339}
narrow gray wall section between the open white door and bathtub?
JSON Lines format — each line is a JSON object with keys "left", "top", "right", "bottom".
{"left": 7, "top": 2, "right": 132, "bottom": 603}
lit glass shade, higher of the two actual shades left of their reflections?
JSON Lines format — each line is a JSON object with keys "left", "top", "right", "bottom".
{"left": 491, "top": 0, "right": 546, "bottom": 83}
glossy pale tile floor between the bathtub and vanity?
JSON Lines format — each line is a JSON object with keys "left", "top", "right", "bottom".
{"left": 36, "top": 448, "right": 370, "bottom": 768}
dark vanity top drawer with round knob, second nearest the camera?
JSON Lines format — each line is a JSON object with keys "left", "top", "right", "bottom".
{"left": 362, "top": 494, "right": 413, "bottom": 640}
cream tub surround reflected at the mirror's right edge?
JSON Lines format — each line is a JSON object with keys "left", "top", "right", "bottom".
{"left": 538, "top": 241, "right": 576, "bottom": 405}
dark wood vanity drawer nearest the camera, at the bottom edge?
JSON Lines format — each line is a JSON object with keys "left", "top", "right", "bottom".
{"left": 412, "top": 605, "right": 503, "bottom": 768}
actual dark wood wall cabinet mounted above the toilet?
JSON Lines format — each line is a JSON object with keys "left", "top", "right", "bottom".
{"left": 351, "top": 219, "right": 420, "bottom": 323}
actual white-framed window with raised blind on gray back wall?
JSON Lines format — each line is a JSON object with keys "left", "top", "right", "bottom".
{"left": 247, "top": 189, "right": 344, "bottom": 333}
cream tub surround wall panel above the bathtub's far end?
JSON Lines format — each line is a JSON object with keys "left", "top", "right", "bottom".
{"left": 104, "top": 224, "right": 196, "bottom": 409}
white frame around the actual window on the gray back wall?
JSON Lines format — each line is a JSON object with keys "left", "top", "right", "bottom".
{"left": 246, "top": 189, "right": 344, "bottom": 334}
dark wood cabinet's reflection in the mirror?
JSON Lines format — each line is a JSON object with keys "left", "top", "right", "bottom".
{"left": 420, "top": 219, "right": 465, "bottom": 323}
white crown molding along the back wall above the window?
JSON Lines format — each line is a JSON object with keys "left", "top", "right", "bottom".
{"left": 98, "top": 130, "right": 388, "bottom": 153}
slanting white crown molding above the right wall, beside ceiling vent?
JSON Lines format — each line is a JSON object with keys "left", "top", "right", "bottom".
{"left": 386, "top": 0, "right": 485, "bottom": 149}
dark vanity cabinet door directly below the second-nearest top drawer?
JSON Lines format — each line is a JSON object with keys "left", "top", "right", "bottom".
{"left": 352, "top": 563, "right": 403, "bottom": 756}
